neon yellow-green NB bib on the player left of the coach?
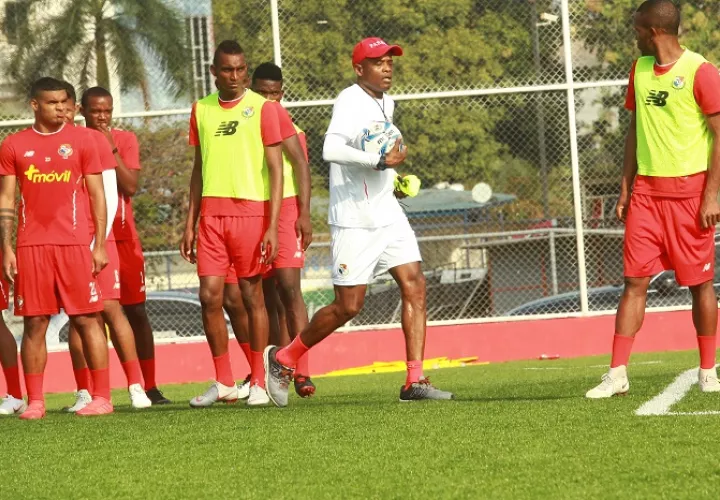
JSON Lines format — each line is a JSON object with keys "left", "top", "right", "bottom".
{"left": 195, "top": 90, "right": 270, "bottom": 201}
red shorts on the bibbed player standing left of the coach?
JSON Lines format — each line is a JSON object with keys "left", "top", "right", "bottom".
{"left": 197, "top": 216, "right": 268, "bottom": 278}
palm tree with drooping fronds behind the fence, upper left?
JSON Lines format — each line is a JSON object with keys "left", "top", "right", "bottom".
{"left": 10, "top": 0, "right": 190, "bottom": 109}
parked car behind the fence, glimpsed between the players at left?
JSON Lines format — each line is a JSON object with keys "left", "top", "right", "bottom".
{"left": 48, "top": 291, "right": 232, "bottom": 344}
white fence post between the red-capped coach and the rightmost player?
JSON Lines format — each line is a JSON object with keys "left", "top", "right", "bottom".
{"left": 561, "top": 0, "right": 588, "bottom": 313}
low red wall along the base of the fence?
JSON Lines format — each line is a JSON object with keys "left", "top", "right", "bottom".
{"left": 2, "top": 311, "right": 697, "bottom": 394}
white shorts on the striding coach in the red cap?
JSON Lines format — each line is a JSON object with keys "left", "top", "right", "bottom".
{"left": 330, "top": 218, "right": 422, "bottom": 286}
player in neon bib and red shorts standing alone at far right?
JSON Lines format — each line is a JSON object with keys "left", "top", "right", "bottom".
{"left": 586, "top": 0, "right": 720, "bottom": 399}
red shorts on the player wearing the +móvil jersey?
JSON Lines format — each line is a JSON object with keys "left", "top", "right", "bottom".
{"left": 15, "top": 245, "right": 103, "bottom": 316}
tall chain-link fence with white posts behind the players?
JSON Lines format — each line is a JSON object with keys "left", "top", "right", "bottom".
{"left": 0, "top": 0, "right": 720, "bottom": 336}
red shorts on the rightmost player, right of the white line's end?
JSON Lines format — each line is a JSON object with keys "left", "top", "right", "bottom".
{"left": 623, "top": 193, "right": 715, "bottom": 286}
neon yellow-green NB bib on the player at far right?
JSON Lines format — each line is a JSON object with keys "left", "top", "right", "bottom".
{"left": 635, "top": 50, "right": 712, "bottom": 177}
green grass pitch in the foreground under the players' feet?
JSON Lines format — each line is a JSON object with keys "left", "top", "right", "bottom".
{"left": 0, "top": 352, "right": 720, "bottom": 499}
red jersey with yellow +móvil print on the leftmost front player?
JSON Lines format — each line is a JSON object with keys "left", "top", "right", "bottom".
{"left": 0, "top": 125, "right": 103, "bottom": 247}
